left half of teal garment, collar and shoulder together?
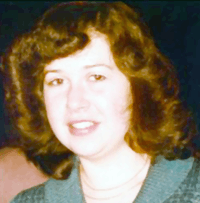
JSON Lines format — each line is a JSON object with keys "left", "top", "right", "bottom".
{"left": 11, "top": 164, "right": 82, "bottom": 203}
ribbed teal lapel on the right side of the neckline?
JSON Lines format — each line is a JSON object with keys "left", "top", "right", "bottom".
{"left": 134, "top": 157, "right": 194, "bottom": 203}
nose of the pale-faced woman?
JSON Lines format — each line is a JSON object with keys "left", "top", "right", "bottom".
{"left": 67, "top": 84, "right": 90, "bottom": 112}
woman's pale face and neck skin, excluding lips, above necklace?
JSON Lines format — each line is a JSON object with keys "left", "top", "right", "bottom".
{"left": 44, "top": 33, "right": 149, "bottom": 201}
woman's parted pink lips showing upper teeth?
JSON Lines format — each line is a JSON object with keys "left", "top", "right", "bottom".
{"left": 68, "top": 120, "right": 99, "bottom": 136}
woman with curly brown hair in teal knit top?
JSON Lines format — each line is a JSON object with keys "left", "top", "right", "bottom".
{"left": 4, "top": 2, "right": 200, "bottom": 203}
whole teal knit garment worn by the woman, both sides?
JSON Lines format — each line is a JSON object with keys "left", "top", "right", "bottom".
{"left": 11, "top": 157, "right": 200, "bottom": 203}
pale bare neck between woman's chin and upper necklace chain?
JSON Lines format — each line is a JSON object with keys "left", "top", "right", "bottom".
{"left": 80, "top": 144, "right": 150, "bottom": 189}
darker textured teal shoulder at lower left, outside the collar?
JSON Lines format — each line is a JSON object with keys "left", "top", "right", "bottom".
{"left": 11, "top": 184, "right": 45, "bottom": 203}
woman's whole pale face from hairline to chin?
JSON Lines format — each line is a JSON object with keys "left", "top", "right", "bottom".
{"left": 44, "top": 35, "right": 132, "bottom": 160}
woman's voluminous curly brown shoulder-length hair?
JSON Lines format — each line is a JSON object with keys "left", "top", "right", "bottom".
{"left": 3, "top": 1, "right": 199, "bottom": 179}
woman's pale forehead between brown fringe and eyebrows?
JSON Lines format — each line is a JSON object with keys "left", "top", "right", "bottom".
{"left": 45, "top": 33, "right": 115, "bottom": 70}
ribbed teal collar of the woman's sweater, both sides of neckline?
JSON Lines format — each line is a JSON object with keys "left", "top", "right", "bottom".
{"left": 45, "top": 157, "right": 194, "bottom": 203}
